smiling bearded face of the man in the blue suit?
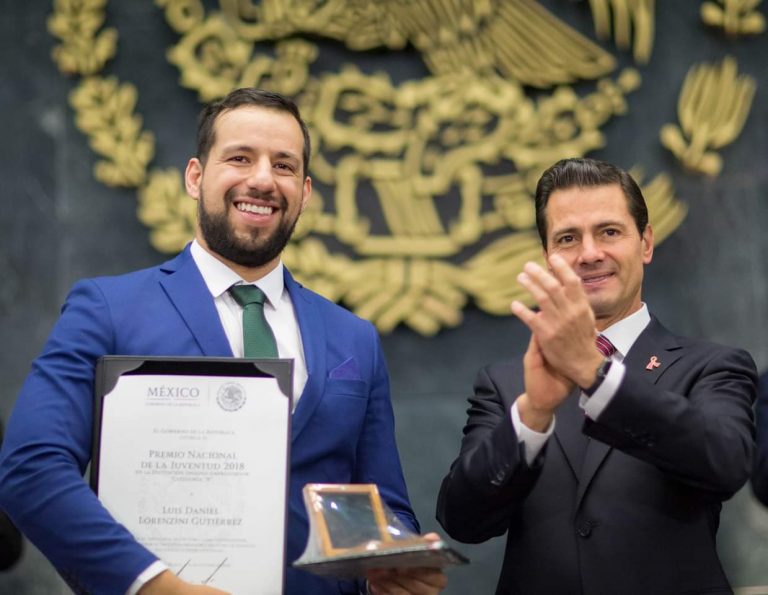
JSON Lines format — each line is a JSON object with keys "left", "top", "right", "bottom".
{"left": 185, "top": 105, "right": 312, "bottom": 281}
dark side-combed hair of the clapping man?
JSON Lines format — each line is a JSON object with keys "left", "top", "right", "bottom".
{"left": 535, "top": 157, "right": 648, "bottom": 250}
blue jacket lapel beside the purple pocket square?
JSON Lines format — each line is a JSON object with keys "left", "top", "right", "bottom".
{"left": 285, "top": 269, "right": 327, "bottom": 441}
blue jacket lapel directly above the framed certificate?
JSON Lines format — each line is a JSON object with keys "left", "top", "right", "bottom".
{"left": 160, "top": 246, "right": 232, "bottom": 357}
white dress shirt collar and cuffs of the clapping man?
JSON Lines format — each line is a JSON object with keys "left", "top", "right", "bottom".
{"left": 510, "top": 304, "right": 651, "bottom": 465}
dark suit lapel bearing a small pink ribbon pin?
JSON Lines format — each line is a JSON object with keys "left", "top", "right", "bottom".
{"left": 576, "top": 317, "right": 682, "bottom": 510}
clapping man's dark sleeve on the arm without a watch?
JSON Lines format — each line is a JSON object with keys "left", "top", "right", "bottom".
{"left": 437, "top": 366, "right": 547, "bottom": 543}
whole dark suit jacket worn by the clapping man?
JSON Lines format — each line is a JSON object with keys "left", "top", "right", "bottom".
{"left": 437, "top": 319, "right": 756, "bottom": 595}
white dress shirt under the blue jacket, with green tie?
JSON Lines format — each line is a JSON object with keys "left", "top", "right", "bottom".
{"left": 126, "top": 240, "right": 308, "bottom": 595}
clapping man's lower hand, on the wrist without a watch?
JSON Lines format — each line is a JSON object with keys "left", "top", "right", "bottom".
{"left": 517, "top": 334, "right": 573, "bottom": 432}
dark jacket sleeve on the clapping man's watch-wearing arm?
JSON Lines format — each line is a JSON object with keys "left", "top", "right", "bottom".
{"left": 584, "top": 344, "right": 757, "bottom": 499}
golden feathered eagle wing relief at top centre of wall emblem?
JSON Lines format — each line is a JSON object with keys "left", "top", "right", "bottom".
{"left": 220, "top": 0, "right": 615, "bottom": 88}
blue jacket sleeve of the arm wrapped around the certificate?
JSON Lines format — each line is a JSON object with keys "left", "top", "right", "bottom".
{"left": 0, "top": 281, "right": 156, "bottom": 593}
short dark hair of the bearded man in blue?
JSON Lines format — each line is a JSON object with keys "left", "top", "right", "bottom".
{"left": 197, "top": 87, "right": 311, "bottom": 176}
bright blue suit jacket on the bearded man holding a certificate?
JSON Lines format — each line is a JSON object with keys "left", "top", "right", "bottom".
{"left": 0, "top": 248, "right": 418, "bottom": 595}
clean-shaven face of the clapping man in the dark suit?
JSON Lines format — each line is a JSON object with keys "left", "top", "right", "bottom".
{"left": 546, "top": 184, "right": 653, "bottom": 330}
